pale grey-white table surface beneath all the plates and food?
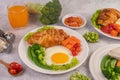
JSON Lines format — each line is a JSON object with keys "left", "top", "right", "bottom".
{"left": 0, "top": 0, "right": 120, "bottom": 80}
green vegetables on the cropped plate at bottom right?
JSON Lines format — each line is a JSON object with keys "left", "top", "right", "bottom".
{"left": 100, "top": 55, "right": 120, "bottom": 80}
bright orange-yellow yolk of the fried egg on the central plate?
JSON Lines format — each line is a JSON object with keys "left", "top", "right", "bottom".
{"left": 51, "top": 53, "right": 69, "bottom": 64}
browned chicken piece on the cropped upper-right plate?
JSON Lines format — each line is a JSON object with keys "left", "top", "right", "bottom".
{"left": 97, "top": 8, "right": 120, "bottom": 26}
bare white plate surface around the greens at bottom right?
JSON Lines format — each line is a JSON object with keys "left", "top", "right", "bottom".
{"left": 89, "top": 44, "right": 120, "bottom": 80}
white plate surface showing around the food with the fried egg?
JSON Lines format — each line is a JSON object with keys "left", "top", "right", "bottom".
{"left": 18, "top": 26, "right": 89, "bottom": 74}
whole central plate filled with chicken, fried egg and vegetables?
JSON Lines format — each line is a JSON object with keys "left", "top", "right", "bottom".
{"left": 19, "top": 26, "right": 88, "bottom": 74}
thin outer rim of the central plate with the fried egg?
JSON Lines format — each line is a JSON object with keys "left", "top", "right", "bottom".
{"left": 18, "top": 25, "right": 89, "bottom": 74}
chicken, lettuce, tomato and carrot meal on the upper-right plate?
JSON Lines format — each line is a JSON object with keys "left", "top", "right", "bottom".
{"left": 91, "top": 8, "right": 120, "bottom": 37}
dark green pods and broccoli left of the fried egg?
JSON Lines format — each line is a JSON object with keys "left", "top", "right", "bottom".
{"left": 27, "top": 44, "right": 52, "bottom": 70}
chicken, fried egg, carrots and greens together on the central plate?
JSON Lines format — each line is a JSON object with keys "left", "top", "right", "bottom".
{"left": 24, "top": 26, "right": 82, "bottom": 71}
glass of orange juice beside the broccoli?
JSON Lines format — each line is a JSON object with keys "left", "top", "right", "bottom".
{"left": 8, "top": 4, "right": 28, "bottom": 29}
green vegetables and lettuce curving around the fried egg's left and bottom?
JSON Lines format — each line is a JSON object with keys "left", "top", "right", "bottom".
{"left": 28, "top": 44, "right": 79, "bottom": 71}
